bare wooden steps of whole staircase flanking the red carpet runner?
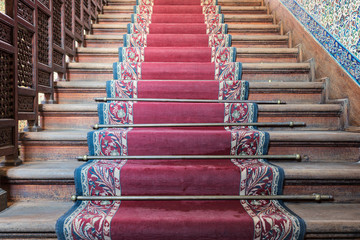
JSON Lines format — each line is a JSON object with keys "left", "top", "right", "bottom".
{"left": 0, "top": 0, "right": 360, "bottom": 239}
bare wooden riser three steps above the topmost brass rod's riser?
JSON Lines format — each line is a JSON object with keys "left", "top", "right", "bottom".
{"left": 84, "top": 40, "right": 288, "bottom": 48}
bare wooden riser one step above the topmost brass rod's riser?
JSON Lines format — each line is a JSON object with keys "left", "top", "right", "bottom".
{"left": 67, "top": 69, "right": 310, "bottom": 82}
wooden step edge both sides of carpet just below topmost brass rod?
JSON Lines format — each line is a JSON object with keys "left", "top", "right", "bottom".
{"left": 39, "top": 102, "right": 342, "bottom": 114}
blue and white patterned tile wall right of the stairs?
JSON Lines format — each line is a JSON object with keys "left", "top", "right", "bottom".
{"left": 281, "top": 0, "right": 360, "bottom": 85}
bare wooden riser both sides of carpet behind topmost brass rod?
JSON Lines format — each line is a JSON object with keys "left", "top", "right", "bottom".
{"left": 55, "top": 89, "right": 322, "bottom": 104}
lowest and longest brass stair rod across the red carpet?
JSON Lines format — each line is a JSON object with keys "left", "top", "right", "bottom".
{"left": 71, "top": 193, "right": 333, "bottom": 201}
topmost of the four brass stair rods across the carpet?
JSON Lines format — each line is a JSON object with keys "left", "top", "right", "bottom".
{"left": 94, "top": 97, "right": 286, "bottom": 104}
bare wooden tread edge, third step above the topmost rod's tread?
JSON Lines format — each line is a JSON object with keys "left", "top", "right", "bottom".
{"left": 77, "top": 47, "right": 299, "bottom": 55}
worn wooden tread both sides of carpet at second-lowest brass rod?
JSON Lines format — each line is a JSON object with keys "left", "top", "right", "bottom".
{"left": 0, "top": 160, "right": 360, "bottom": 180}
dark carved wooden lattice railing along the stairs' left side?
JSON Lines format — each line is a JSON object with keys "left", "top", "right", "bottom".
{"left": 0, "top": 0, "right": 106, "bottom": 163}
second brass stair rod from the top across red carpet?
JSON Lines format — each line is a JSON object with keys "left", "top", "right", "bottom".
{"left": 93, "top": 122, "right": 306, "bottom": 129}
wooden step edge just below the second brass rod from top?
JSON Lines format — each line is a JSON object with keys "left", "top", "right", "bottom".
{"left": 20, "top": 130, "right": 360, "bottom": 142}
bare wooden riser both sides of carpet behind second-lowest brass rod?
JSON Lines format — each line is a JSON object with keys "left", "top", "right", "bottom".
{"left": 20, "top": 140, "right": 360, "bottom": 162}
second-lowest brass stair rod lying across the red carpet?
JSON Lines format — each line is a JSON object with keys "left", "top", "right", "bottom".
{"left": 76, "top": 154, "right": 301, "bottom": 162}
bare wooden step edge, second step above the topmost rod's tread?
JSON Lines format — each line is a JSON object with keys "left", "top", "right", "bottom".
{"left": 67, "top": 62, "right": 311, "bottom": 71}
